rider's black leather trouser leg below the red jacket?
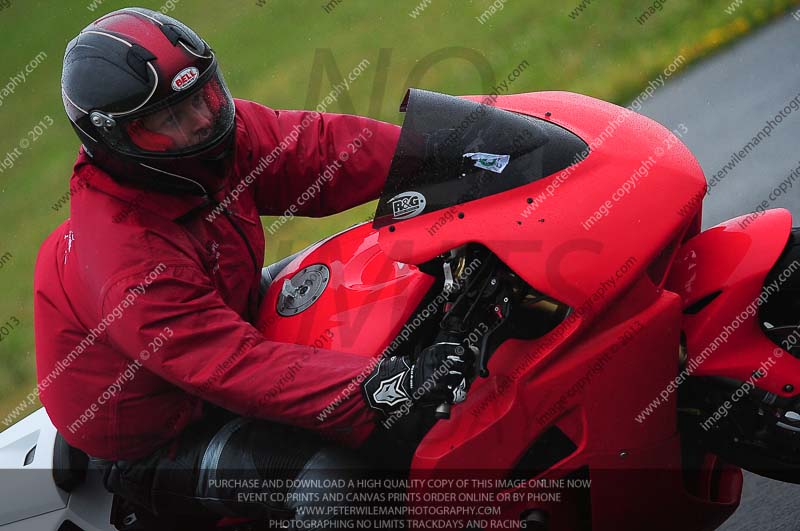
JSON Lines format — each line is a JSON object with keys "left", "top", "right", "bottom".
{"left": 105, "top": 414, "right": 384, "bottom": 529}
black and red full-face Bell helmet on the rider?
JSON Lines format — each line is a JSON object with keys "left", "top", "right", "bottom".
{"left": 61, "top": 7, "right": 235, "bottom": 195}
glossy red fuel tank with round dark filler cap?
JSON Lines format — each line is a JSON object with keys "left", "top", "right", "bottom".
{"left": 256, "top": 223, "right": 434, "bottom": 356}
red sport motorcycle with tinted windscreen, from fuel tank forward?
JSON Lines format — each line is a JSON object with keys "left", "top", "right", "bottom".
{"left": 253, "top": 90, "right": 800, "bottom": 531}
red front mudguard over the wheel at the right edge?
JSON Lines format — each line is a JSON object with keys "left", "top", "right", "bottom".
{"left": 667, "top": 209, "right": 800, "bottom": 397}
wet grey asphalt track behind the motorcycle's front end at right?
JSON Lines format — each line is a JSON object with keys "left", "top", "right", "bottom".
{"left": 641, "top": 12, "right": 800, "bottom": 531}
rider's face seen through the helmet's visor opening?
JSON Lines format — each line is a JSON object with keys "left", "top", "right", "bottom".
{"left": 142, "top": 92, "right": 213, "bottom": 149}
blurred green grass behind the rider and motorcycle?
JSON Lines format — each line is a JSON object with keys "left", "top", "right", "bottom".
{"left": 0, "top": 0, "right": 798, "bottom": 429}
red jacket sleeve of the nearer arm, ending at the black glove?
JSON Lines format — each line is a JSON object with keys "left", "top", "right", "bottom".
{"left": 102, "top": 264, "right": 375, "bottom": 446}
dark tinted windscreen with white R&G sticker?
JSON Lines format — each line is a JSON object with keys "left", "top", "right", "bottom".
{"left": 373, "top": 89, "right": 586, "bottom": 228}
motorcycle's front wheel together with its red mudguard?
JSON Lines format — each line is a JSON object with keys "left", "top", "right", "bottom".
{"left": 668, "top": 209, "right": 800, "bottom": 483}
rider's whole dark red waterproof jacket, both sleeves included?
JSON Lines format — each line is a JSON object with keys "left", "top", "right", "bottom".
{"left": 34, "top": 100, "right": 399, "bottom": 459}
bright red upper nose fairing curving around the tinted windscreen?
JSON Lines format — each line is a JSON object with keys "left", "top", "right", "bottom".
{"left": 379, "top": 92, "right": 706, "bottom": 313}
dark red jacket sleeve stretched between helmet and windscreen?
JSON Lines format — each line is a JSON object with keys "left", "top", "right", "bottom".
{"left": 237, "top": 101, "right": 400, "bottom": 217}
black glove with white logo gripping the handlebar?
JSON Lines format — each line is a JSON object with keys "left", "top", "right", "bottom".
{"left": 361, "top": 343, "right": 475, "bottom": 415}
